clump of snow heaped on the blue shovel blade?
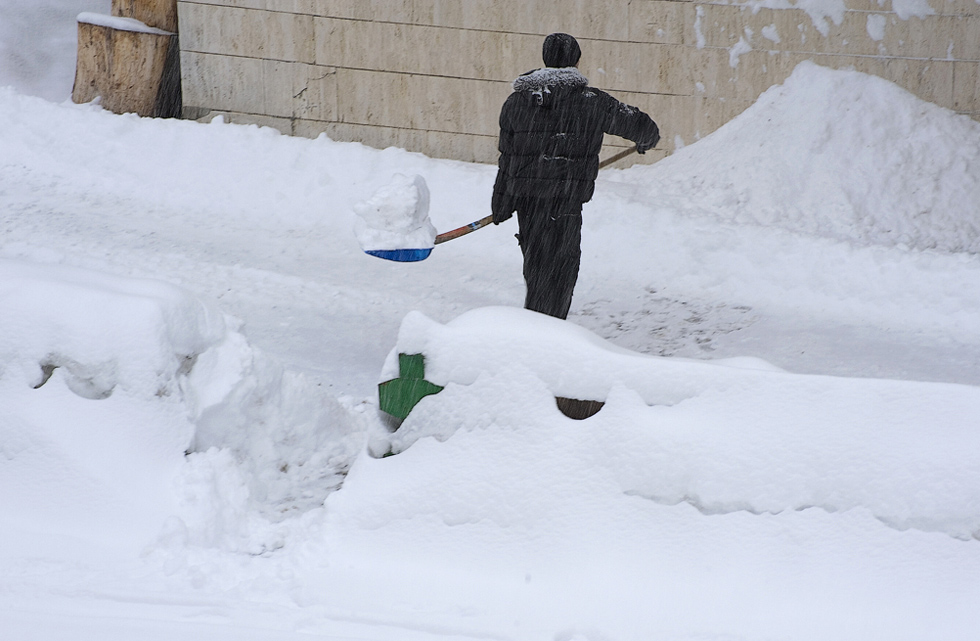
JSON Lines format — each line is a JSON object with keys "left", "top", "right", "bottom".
{"left": 354, "top": 174, "right": 436, "bottom": 251}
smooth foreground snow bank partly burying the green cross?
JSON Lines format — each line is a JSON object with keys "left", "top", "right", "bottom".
{"left": 296, "top": 308, "right": 980, "bottom": 641}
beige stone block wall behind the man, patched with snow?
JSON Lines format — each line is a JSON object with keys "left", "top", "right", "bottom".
{"left": 178, "top": 0, "right": 980, "bottom": 164}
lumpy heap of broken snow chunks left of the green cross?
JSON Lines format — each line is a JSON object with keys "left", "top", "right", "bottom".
{"left": 181, "top": 334, "right": 366, "bottom": 552}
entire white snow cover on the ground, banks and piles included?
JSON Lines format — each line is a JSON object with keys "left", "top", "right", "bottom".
{"left": 0, "top": 3, "right": 980, "bottom": 641}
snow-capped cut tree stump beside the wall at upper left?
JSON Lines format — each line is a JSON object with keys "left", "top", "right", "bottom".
{"left": 72, "top": 13, "right": 179, "bottom": 117}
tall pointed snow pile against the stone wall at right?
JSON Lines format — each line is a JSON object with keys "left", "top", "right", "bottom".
{"left": 618, "top": 62, "right": 980, "bottom": 253}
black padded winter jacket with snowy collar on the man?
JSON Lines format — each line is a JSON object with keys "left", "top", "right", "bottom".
{"left": 494, "top": 67, "right": 660, "bottom": 205}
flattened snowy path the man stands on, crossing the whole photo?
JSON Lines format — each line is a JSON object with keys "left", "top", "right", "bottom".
{"left": 0, "top": 94, "right": 980, "bottom": 390}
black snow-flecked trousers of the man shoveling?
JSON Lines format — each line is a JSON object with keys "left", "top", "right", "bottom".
{"left": 517, "top": 198, "right": 582, "bottom": 318}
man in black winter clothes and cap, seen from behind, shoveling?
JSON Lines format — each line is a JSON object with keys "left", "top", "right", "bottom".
{"left": 491, "top": 33, "right": 660, "bottom": 318}
